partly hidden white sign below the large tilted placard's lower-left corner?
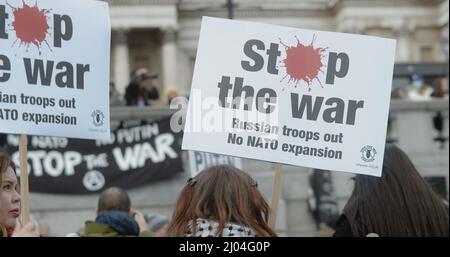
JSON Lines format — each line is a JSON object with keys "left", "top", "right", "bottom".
{"left": 188, "top": 151, "right": 242, "bottom": 177}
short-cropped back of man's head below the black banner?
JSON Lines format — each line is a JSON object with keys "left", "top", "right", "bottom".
{"left": 97, "top": 187, "right": 131, "bottom": 214}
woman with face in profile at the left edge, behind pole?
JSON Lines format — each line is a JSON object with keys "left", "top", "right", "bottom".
{"left": 0, "top": 151, "right": 38, "bottom": 237}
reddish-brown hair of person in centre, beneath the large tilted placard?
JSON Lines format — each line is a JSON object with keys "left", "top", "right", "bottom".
{"left": 167, "top": 165, "right": 276, "bottom": 236}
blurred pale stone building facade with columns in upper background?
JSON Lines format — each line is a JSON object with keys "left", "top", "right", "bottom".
{"left": 108, "top": 0, "right": 449, "bottom": 95}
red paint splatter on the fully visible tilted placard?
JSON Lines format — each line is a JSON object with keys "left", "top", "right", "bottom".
{"left": 280, "top": 35, "right": 327, "bottom": 91}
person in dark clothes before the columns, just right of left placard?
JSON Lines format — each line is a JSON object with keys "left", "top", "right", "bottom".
{"left": 125, "top": 68, "right": 159, "bottom": 106}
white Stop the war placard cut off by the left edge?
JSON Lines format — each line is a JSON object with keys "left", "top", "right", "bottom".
{"left": 0, "top": 0, "right": 111, "bottom": 139}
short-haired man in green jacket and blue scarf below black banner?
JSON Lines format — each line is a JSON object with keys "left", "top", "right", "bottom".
{"left": 77, "top": 187, "right": 153, "bottom": 237}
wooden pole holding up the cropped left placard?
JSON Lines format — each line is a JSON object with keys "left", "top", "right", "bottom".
{"left": 19, "top": 134, "right": 30, "bottom": 225}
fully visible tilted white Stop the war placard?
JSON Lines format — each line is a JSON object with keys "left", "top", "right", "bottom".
{"left": 182, "top": 17, "right": 395, "bottom": 176}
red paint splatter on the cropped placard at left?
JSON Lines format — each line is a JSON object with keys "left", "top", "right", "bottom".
{"left": 7, "top": 0, "right": 51, "bottom": 54}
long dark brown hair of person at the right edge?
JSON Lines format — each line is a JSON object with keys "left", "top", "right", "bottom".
{"left": 343, "top": 144, "right": 449, "bottom": 236}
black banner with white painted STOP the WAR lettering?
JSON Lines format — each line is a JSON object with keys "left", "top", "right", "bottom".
{"left": 7, "top": 118, "right": 183, "bottom": 194}
